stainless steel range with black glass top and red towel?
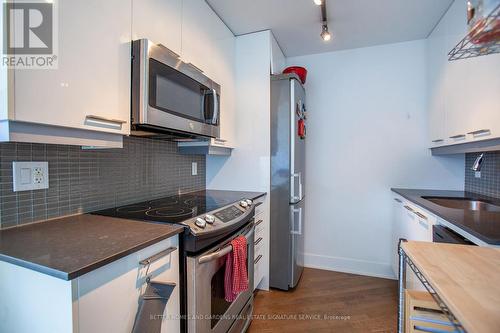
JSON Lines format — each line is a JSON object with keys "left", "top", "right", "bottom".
{"left": 94, "top": 190, "right": 255, "bottom": 333}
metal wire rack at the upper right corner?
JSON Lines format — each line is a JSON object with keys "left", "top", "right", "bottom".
{"left": 448, "top": 5, "right": 500, "bottom": 61}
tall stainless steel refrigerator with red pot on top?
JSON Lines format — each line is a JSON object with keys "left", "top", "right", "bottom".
{"left": 269, "top": 74, "right": 306, "bottom": 290}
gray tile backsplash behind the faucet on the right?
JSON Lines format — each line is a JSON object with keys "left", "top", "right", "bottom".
{"left": 465, "top": 151, "right": 500, "bottom": 198}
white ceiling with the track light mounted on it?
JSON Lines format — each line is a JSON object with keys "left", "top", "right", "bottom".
{"left": 206, "top": 0, "right": 453, "bottom": 57}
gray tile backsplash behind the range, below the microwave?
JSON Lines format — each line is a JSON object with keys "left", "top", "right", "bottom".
{"left": 0, "top": 137, "right": 205, "bottom": 228}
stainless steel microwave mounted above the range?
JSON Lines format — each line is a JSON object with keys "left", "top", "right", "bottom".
{"left": 132, "top": 39, "right": 220, "bottom": 137}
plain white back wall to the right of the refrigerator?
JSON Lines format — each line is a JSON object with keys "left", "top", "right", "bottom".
{"left": 287, "top": 40, "right": 464, "bottom": 277}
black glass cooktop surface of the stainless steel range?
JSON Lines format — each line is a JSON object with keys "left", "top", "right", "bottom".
{"left": 94, "top": 190, "right": 252, "bottom": 223}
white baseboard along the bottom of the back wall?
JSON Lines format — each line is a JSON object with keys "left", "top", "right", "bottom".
{"left": 304, "top": 253, "right": 396, "bottom": 280}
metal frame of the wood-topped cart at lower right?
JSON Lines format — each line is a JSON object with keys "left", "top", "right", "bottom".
{"left": 398, "top": 240, "right": 467, "bottom": 333}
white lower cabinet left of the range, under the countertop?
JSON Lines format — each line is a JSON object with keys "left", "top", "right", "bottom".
{"left": 0, "top": 236, "right": 180, "bottom": 333}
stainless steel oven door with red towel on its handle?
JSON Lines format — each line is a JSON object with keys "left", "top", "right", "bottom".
{"left": 187, "top": 220, "right": 254, "bottom": 333}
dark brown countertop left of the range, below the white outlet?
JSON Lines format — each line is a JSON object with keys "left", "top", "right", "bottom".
{"left": 0, "top": 214, "right": 183, "bottom": 280}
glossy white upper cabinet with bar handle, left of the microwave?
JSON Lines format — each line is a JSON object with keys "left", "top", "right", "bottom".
{"left": 9, "top": 0, "right": 131, "bottom": 134}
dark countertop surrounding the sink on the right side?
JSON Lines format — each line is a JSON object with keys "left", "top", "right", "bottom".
{"left": 391, "top": 188, "right": 500, "bottom": 245}
